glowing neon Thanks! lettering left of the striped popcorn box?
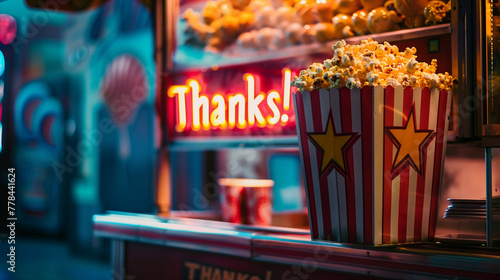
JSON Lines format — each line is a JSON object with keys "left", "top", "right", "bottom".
{"left": 167, "top": 69, "right": 294, "bottom": 132}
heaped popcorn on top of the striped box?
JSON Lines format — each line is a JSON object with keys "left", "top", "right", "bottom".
{"left": 292, "top": 38, "right": 454, "bottom": 91}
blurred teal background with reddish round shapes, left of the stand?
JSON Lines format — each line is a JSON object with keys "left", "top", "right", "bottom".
{"left": 0, "top": 0, "right": 157, "bottom": 279}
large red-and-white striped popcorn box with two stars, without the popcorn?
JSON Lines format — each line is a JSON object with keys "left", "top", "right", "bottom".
{"left": 294, "top": 86, "right": 452, "bottom": 245}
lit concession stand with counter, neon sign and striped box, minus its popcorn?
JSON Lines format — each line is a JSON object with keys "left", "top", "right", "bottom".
{"left": 94, "top": 0, "right": 500, "bottom": 280}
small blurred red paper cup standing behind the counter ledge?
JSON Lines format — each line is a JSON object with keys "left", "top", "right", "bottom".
{"left": 219, "top": 178, "right": 274, "bottom": 226}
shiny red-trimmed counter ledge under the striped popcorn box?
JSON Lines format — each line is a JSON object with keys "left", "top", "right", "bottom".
{"left": 93, "top": 213, "right": 500, "bottom": 279}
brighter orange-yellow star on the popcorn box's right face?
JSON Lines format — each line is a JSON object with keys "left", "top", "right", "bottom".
{"left": 386, "top": 108, "right": 435, "bottom": 176}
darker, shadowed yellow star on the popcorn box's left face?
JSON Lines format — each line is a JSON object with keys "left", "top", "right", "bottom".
{"left": 308, "top": 114, "right": 359, "bottom": 178}
